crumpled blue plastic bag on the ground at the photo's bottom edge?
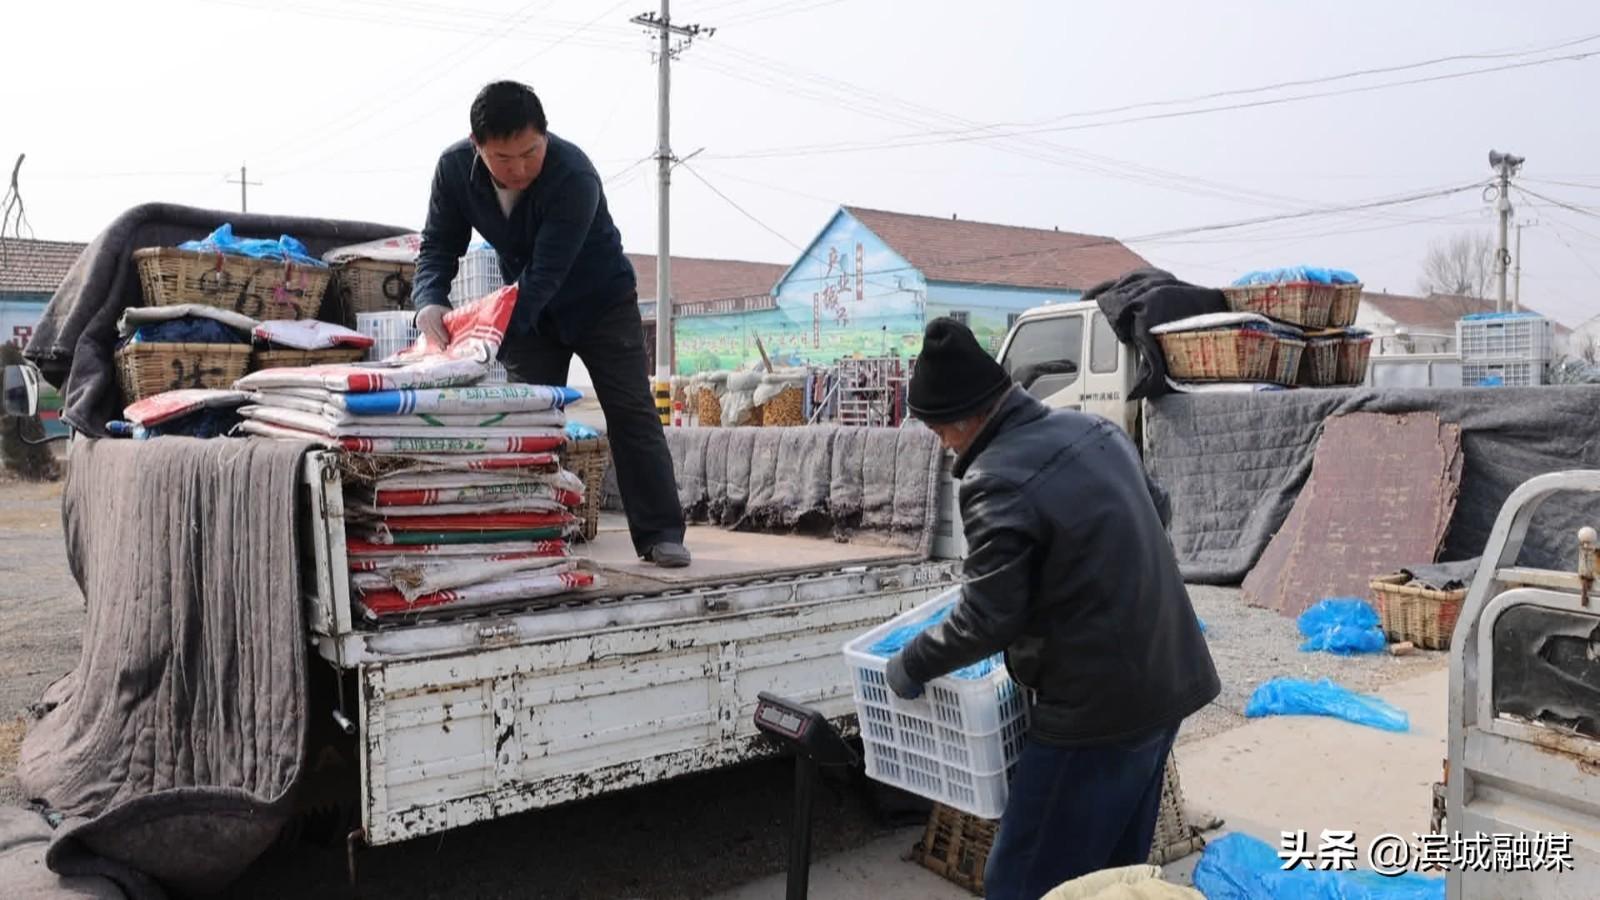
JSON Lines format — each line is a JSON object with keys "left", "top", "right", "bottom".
{"left": 1194, "top": 833, "right": 1445, "bottom": 900}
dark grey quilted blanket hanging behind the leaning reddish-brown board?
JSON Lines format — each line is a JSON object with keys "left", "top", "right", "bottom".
{"left": 1146, "top": 384, "right": 1600, "bottom": 585}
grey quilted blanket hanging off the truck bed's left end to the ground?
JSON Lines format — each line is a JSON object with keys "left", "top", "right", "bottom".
{"left": 16, "top": 437, "right": 309, "bottom": 900}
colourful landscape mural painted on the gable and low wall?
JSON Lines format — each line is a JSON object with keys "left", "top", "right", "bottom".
{"left": 675, "top": 213, "right": 928, "bottom": 375}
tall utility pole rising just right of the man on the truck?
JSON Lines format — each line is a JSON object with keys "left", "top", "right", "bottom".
{"left": 629, "top": 0, "right": 717, "bottom": 424}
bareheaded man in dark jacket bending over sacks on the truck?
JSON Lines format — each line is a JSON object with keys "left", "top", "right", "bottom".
{"left": 411, "top": 82, "right": 690, "bottom": 567}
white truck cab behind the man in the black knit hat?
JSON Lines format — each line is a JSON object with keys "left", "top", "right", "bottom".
{"left": 998, "top": 301, "right": 1139, "bottom": 436}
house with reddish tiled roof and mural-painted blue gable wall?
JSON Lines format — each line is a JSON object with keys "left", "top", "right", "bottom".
{"left": 674, "top": 207, "right": 1147, "bottom": 373}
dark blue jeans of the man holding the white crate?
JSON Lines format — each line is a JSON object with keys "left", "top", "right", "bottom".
{"left": 984, "top": 725, "right": 1178, "bottom": 900}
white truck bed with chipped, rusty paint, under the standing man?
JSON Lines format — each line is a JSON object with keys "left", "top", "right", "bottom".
{"left": 301, "top": 456, "right": 958, "bottom": 846}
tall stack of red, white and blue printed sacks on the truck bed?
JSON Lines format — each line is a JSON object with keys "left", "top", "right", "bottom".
{"left": 238, "top": 288, "right": 595, "bottom": 618}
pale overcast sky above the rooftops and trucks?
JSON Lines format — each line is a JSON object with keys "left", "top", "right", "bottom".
{"left": 9, "top": 0, "right": 1600, "bottom": 323}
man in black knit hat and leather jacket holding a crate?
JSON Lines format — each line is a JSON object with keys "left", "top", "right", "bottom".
{"left": 888, "top": 319, "right": 1221, "bottom": 900}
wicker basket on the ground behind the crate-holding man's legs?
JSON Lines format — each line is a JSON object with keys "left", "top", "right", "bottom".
{"left": 910, "top": 754, "right": 1205, "bottom": 897}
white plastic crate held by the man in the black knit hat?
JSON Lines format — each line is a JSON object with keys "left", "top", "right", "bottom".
{"left": 845, "top": 589, "right": 1027, "bottom": 818}
